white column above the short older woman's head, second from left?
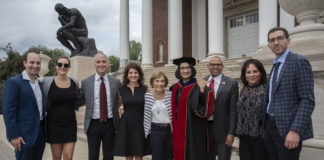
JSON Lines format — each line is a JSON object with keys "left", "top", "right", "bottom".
{"left": 142, "top": 0, "right": 153, "bottom": 69}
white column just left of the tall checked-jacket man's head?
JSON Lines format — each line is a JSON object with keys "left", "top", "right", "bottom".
{"left": 259, "top": 0, "right": 278, "bottom": 47}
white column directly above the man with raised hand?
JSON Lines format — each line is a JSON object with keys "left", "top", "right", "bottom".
{"left": 208, "top": 0, "right": 224, "bottom": 57}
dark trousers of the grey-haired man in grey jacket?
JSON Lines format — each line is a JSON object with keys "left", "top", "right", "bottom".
{"left": 87, "top": 118, "right": 116, "bottom": 160}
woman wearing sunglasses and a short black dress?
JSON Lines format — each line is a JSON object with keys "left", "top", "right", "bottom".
{"left": 44, "top": 57, "right": 78, "bottom": 160}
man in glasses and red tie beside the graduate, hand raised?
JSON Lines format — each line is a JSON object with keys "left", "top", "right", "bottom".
{"left": 205, "top": 56, "right": 238, "bottom": 160}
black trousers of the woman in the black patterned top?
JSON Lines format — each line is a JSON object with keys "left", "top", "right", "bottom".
{"left": 239, "top": 136, "right": 268, "bottom": 160}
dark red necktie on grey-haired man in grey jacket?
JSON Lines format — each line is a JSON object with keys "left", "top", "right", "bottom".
{"left": 99, "top": 77, "right": 108, "bottom": 120}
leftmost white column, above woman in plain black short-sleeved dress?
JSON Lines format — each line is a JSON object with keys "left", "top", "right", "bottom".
{"left": 119, "top": 0, "right": 129, "bottom": 71}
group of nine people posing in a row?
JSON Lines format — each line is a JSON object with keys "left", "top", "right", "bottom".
{"left": 2, "top": 27, "right": 315, "bottom": 160}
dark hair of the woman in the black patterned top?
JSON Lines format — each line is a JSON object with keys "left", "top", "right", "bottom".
{"left": 241, "top": 59, "right": 267, "bottom": 86}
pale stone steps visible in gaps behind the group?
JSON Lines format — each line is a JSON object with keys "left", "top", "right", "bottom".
{"left": 77, "top": 52, "right": 324, "bottom": 160}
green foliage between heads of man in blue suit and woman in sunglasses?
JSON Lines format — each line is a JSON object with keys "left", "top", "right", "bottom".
{"left": 24, "top": 45, "right": 69, "bottom": 76}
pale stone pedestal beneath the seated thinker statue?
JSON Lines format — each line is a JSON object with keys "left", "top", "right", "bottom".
{"left": 68, "top": 56, "right": 96, "bottom": 83}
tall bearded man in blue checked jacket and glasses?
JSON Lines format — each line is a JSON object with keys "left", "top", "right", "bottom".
{"left": 264, "top": 27, "right": 315, "bottom": 160}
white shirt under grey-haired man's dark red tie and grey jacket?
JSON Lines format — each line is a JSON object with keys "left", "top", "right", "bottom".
{"left": 92, "top": 73, "right": 113, "bottom": 119}
